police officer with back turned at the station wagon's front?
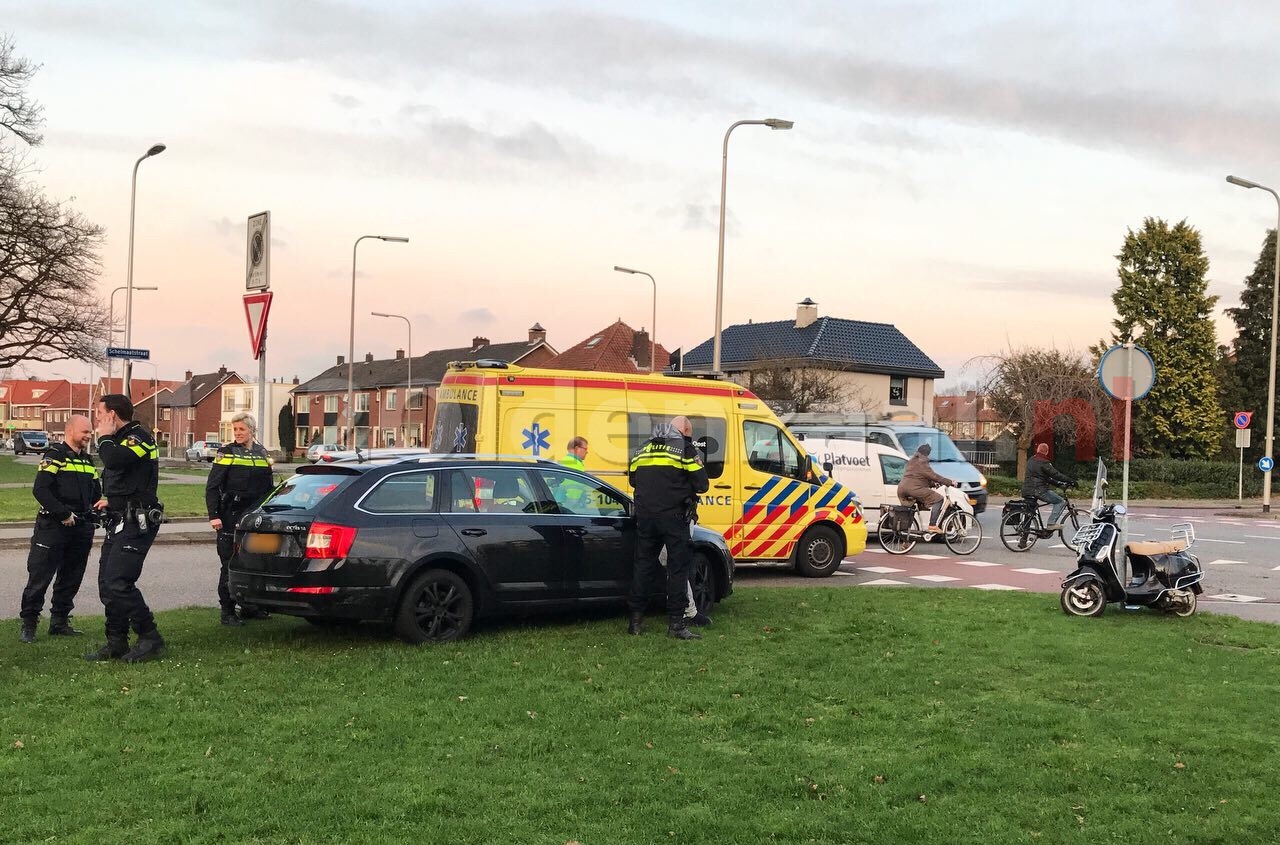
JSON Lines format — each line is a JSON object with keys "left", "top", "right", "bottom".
{"left": 627, "top": 416, "right": 710, "bottom": 640}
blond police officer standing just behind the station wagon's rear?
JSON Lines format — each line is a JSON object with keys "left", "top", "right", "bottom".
{"left": 205, "top": 414, "right": 275, "bottom": 625}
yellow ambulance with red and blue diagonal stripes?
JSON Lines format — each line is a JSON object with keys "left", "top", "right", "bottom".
{"left": 431, "top": 361, "right": 867, "bottom": 577}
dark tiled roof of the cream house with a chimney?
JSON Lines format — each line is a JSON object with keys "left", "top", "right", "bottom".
{"left": 685, "top": 316, "right": 945, "bottom": 379}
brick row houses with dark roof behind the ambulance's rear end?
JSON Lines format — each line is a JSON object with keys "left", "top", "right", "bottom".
{"left": 293, "top": 323, "right": 556, "bottom": 451}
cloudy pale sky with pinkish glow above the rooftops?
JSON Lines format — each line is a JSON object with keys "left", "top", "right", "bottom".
{"left": 0, "top": 0, "right": 1280, "bottom": 383}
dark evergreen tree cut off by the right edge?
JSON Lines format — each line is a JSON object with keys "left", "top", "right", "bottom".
{"left": 1224, "top": 229, "right": 1280, "bottom": 458}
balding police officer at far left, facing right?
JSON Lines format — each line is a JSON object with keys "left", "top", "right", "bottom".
{"left": 22, "top": 414, "right": 102, "bottom": 643}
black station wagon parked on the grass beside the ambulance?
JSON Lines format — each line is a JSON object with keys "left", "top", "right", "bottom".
{"left": 230, "top": 455, "right": 733, "bottom": 643}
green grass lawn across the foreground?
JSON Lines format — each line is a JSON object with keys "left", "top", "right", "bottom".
{"left": 0, "top": 588, "right": 1280, "bottom": 845}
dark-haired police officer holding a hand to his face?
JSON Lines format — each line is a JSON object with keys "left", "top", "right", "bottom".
{"left": 84, "top": 393, "right": 165, "bottom": 663}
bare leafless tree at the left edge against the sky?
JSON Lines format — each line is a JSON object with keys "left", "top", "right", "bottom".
{"left": 0, "top": 37, "right": 108, "bottom": 369}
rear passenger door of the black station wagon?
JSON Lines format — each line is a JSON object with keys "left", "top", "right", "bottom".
{"left": 440, "top": 466, "right": 564, "bottom": 604}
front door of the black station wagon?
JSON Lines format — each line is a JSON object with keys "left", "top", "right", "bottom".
{"left": 534, "top": 467, "right": 636, "bottom": 600}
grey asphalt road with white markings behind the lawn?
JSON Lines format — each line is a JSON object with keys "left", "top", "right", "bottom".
{"left": 0, "top": 507, "right": 1280, "bottom": 622}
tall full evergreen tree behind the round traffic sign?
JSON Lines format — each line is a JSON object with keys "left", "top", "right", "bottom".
{"left": 1111, "top": 218, "right": 1226, "bottom": 458}
